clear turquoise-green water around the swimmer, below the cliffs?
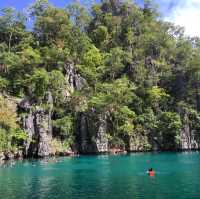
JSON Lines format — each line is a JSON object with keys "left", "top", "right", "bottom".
{"left": 0, "top": 152, "right": 200, "bottom": 199}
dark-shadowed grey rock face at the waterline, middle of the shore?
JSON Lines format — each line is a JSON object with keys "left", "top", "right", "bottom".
{"left": 78, "top": 113, "right": 108, "bottom": 154}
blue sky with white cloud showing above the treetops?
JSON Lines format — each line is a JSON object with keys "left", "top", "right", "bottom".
{"left": 0, "top": 0, "right": 200, "bottom": 36}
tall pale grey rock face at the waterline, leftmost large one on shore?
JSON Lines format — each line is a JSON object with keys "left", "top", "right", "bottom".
{"left": 19, "top": 93, "right": 53, "bottom": 157}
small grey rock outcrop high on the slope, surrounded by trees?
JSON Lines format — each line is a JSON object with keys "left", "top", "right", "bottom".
{"left": 64, "top": 62, "right": 87, "bottom": 92}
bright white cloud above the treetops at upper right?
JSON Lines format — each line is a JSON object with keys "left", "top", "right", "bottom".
{"left": 165, "top": 0, "right": 200, "bottom": 37}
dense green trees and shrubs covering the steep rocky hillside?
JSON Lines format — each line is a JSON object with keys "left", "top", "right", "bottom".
{"left": 0, "top": 0, "right": 200, "bottom": 150}
